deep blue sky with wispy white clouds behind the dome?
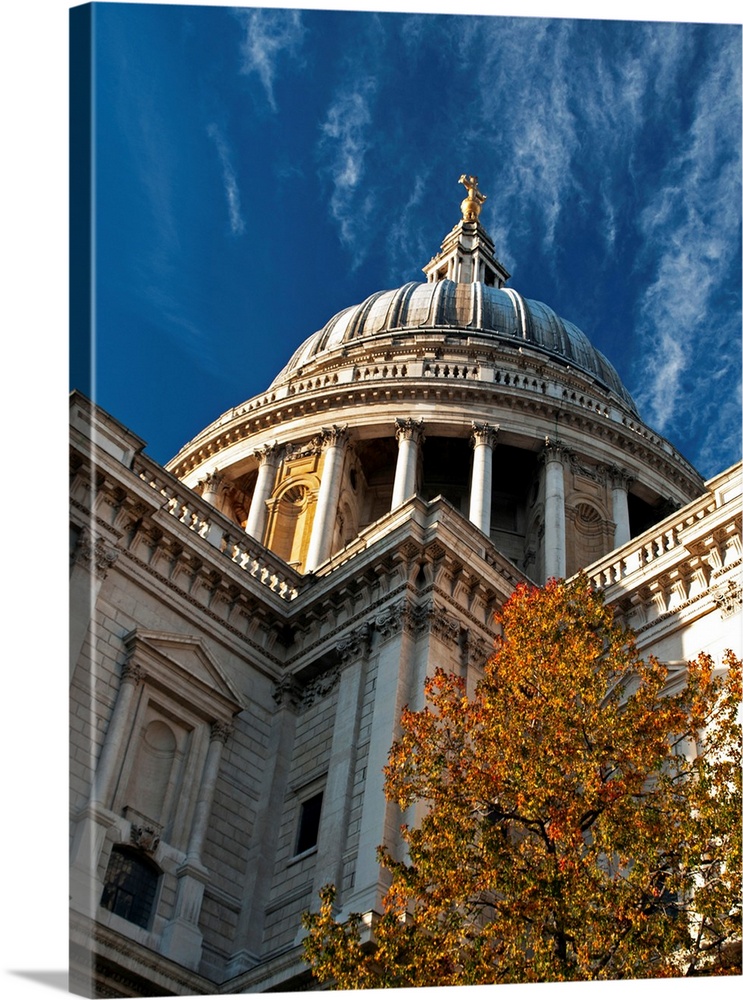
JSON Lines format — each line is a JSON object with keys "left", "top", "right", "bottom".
{"left": 73, "top": 4, "right": 741, "bottom": 477}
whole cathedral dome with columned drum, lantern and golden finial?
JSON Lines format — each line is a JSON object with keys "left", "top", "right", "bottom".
{"left": 169, "top": 175, "right": 702, "bottom": 583}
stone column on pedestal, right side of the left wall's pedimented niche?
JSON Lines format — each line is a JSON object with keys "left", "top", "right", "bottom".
{"left": 162, "top": 722, "right": 232, "bottom": 969}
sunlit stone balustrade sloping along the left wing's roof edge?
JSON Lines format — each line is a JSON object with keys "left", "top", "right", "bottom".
{"left": 134, "top": 455, "right": 302, "bottom": 601}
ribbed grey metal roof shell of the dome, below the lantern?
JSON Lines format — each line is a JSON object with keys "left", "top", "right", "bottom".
{"left": 272, "top": 279, "right": 637, "bottom": 413}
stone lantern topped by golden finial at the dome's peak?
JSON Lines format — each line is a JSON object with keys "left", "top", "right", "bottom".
{"left": 423, "top": 174, "right": 511, "bottom": 288}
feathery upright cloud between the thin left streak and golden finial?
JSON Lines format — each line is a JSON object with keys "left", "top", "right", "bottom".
{"left": 319, "top": 78, "right": 376, "bottom": 266}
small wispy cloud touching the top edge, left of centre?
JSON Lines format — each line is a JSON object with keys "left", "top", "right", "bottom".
{"left": 238, "top": 9, "right": 305, "bottom": 112}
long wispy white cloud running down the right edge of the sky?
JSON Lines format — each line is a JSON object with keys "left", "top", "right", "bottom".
{"left": 636, "top": 31, "right": 741, "bottom": 464}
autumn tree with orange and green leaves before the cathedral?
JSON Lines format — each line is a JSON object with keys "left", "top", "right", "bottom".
{"left": 304, "top": 577, "right": 741, "bottom": 989}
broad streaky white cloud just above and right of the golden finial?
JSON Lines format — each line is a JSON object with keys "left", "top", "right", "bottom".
{"left": 459, "top": 18, "right": 704, "bottom": 274}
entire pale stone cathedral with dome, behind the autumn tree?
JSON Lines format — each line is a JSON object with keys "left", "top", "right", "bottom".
{"left": 70, "top": 176, "right": 741, "bottom": 997}
